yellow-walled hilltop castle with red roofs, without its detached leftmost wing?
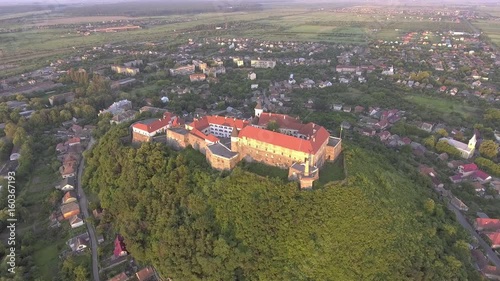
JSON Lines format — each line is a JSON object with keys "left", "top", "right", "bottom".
{"left": 166, "top": 101, "right": 342, "bottom": 188}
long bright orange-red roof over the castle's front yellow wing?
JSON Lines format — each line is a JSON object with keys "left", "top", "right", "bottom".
{"left": 239, "top": 126, "right": 330, "bottom": 154}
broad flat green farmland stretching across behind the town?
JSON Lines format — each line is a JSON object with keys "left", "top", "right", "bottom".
{"left": 0, "top": 4, "right": 480, "bottom": 76}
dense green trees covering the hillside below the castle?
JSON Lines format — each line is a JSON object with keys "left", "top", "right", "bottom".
{"left": 84, "top": 127, "right": 481, "bottom": 281}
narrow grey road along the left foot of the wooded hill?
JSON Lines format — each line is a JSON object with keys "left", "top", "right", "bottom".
{"left": 77, "top": 138, "right": 100, "bottom": 281}
